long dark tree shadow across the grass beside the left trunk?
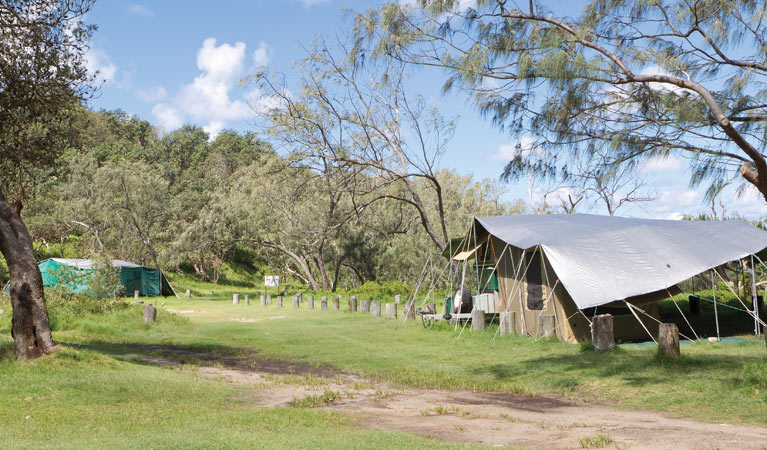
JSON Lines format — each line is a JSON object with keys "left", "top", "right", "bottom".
{"left": 56, "top": 341, "right": 338, "bottom": 378}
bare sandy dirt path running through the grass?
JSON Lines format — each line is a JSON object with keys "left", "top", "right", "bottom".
{"left": 124, "top": 347, "right": 767, "bottom": 449}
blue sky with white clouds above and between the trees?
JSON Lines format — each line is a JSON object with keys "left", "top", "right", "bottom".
{"left": 87, "top": 0, "right": 767, "bottom": 218}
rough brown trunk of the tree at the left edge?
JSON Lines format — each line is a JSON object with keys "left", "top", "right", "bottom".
{"left": 0, "top": 192, "right": 55, "bottom": 359}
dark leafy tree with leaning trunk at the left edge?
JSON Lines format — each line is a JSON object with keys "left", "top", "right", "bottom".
{"left": 0, "top": 0, "right": 93, "bottom": 359}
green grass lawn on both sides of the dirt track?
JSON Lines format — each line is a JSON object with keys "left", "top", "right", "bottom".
{"left": 0, "top": 285, "right": 767, "bottom": 448}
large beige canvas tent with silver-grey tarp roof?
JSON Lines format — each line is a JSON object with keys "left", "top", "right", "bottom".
{"left": 416, "top": 214, "right": 767, "bottom": 343}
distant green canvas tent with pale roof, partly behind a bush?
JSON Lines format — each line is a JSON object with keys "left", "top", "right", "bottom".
{"left": 38, "top": 258, "right": 175, "bottom": 297}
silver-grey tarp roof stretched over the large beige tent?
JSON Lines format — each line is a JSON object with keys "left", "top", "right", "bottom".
{"left": 476, "top": 214, "right": 767, "bottom": 308}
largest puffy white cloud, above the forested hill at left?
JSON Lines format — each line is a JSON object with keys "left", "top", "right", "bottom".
{"left": 152, "top": 38, "right": 268, "bottom": 138}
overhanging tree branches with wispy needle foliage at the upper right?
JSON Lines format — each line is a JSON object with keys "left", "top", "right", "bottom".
{"left": 354, "top": 0, "right": 767, "bottom": 204}
